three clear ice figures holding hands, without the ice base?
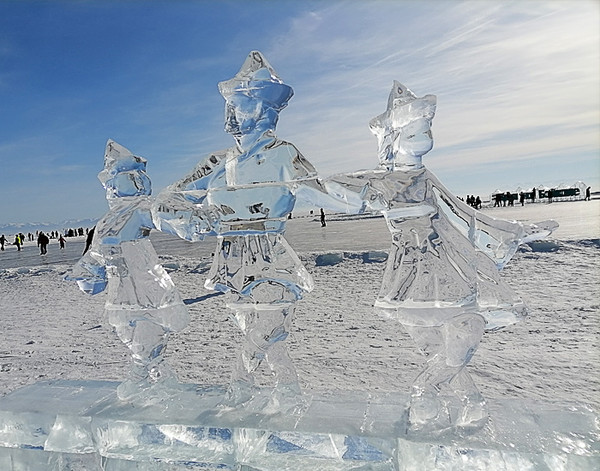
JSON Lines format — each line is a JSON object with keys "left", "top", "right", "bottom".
{"left": 70, "top": 51, "right": 556, "bottom": 433}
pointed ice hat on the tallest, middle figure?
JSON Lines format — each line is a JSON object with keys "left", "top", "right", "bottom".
{"left": 219, "top": 51, "right": 294, "bottom": 111}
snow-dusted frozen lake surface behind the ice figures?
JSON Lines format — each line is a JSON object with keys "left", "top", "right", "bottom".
{"left": 0, "top": 200, "right": 600, "bottom": 408}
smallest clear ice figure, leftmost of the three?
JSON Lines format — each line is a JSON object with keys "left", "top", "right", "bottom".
{"left": 67, "top": 140, "right": 189, "bottom": 399}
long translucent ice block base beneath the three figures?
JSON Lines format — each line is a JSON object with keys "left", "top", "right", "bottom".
{"left": 0, "top": 381, "right": 600, "bottom": 471}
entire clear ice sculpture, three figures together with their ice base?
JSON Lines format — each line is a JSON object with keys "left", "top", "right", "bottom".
{"left": 0, "top": 51, "right": 600, "bottom": 471}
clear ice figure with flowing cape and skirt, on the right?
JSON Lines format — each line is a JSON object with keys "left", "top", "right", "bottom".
{"left": 326, "top": 82, "right": 557, "bottom": 432}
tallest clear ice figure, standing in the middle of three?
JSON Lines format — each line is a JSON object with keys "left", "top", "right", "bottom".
{"left": 153, "top": 51, "right": 323, "bottom": 408}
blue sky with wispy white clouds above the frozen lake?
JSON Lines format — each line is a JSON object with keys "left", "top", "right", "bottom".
{"left": 0, "top": 0, "right": 600, "bottom": 224}
